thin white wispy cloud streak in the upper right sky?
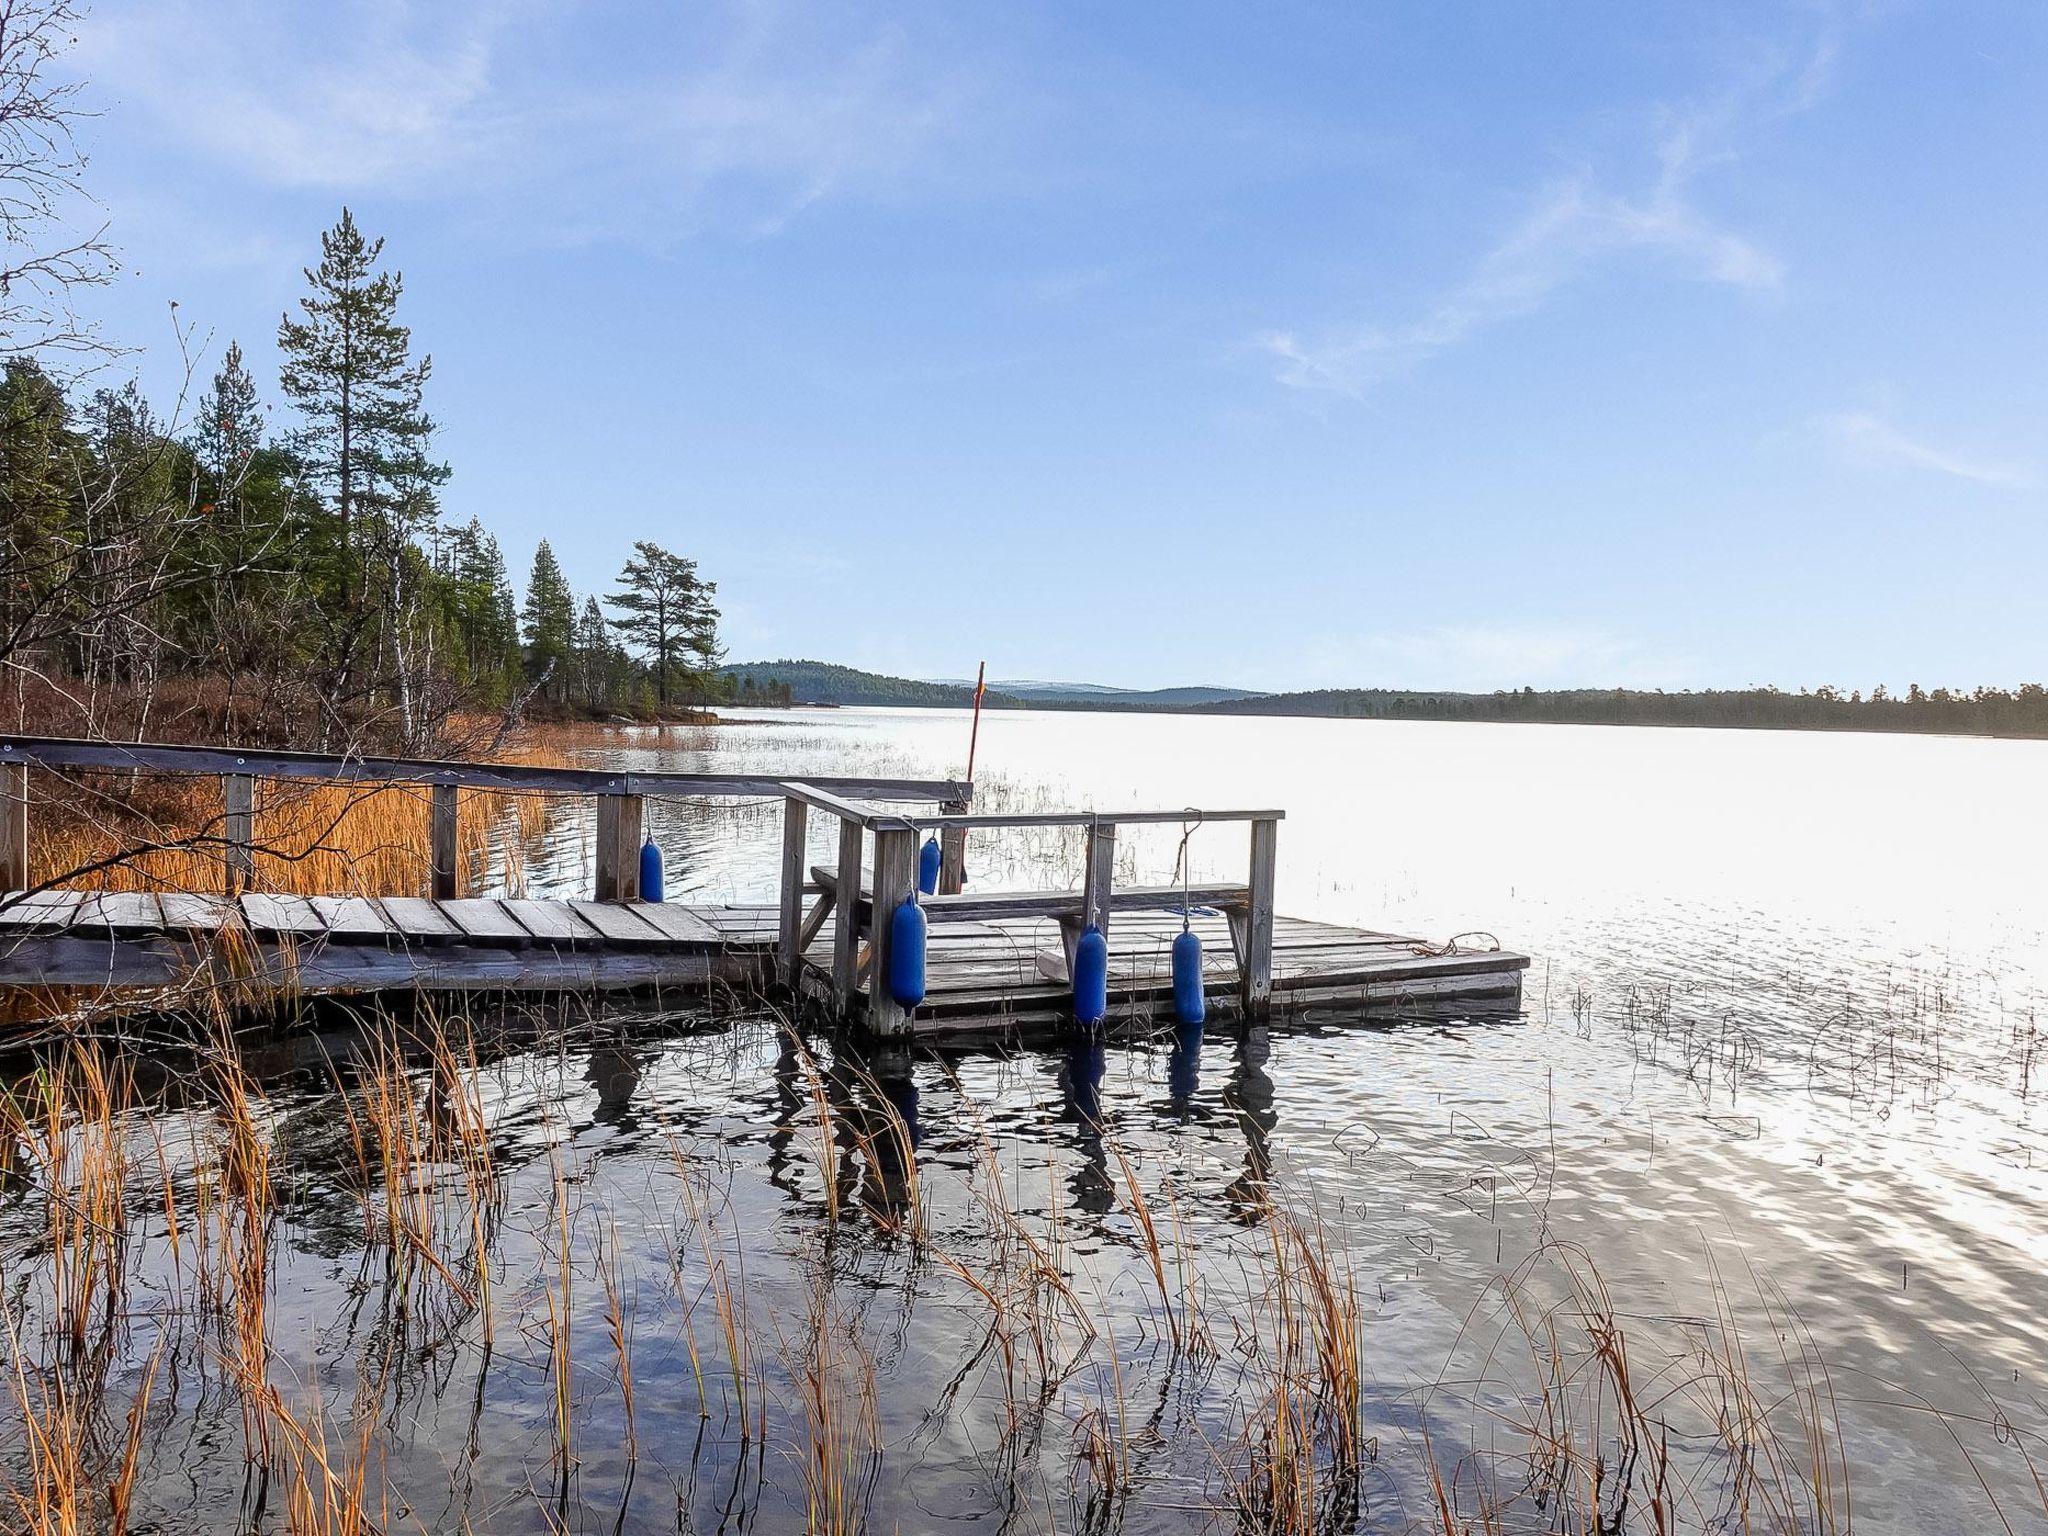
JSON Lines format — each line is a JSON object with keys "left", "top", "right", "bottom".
{"left": 1255, "top": 31, "right": 1837, "bottom": 395}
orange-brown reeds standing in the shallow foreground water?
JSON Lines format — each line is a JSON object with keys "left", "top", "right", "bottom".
{"left": 0, "top": 1014, "right": 2048, "bottom": 1536}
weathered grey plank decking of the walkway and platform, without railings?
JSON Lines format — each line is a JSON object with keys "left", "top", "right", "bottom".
{"left": 0, "top": 891, "right": 1528, "bottom": 1036}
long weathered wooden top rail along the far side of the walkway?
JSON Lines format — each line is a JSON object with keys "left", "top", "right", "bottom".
{"left": 0, "top": 735, "right": 973, "bottom": 805}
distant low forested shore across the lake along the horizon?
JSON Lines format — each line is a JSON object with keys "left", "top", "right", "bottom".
{"left": 723, "top": 662, "right": 2048, "bottom": 739}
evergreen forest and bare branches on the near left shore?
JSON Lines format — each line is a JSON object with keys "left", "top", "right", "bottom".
{"left": 0, "top": 0, "right": 782, "bottom": 754}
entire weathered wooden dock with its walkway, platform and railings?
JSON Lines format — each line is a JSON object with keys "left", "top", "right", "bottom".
{"left": 0, "top": 737, "right": 1528, "bottom": 1036}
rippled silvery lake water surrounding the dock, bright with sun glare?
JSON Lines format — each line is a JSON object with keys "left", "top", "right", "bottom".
{"left": 0, "top": 711, "right": 2048, "bottom": 1532}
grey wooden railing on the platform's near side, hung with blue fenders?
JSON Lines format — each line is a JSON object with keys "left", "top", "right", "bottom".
{"left": 778, "top": 794, "right": 1286, "bottom": 1034}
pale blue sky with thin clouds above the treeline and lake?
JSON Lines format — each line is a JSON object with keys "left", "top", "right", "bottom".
{"left": 56, "top": 0, "right": 2048, "bottom": 688}
